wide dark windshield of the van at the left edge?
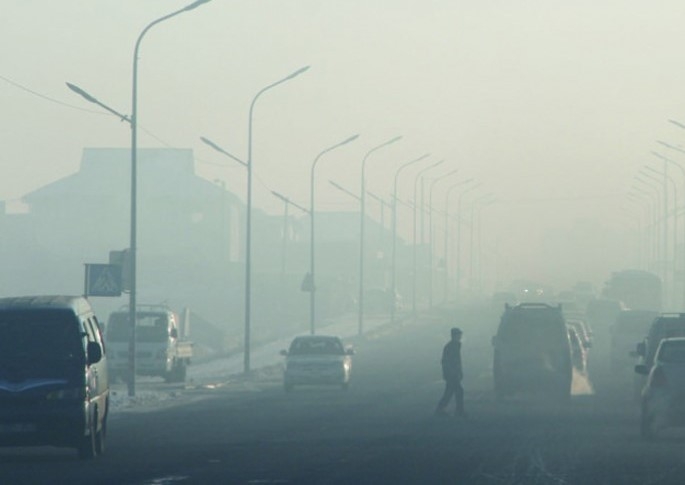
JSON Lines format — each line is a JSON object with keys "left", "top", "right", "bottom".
{"left": 0, "top": 309, "right": 85, "bottom": 364}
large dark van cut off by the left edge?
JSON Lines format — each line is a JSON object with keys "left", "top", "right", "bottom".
{"left": 0, "top": 296, "right": 109, "bottom": 459}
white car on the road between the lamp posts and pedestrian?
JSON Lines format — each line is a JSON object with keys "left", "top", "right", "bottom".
{"left": 281, "top": 335, "right": 354, "bottom": 392}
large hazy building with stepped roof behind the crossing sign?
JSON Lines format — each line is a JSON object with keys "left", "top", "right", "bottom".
{"left": 0, "top": 148, "right": 245, "bottom": 326}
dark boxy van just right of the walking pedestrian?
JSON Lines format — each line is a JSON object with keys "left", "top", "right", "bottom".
{"left": 492, "top": 303, "right": 573, "bottom": 399}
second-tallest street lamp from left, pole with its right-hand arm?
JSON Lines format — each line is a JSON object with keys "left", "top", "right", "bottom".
{"left": 243, "top": 66, "right": 309, "bottom": 374}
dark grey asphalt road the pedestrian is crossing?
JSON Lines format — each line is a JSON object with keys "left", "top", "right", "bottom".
{"left": 0, "top": 311, "right": 685, "bottom": 485}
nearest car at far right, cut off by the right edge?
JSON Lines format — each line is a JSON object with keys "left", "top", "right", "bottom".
{"left": 635, "top": 337, "right": 685, "bottom": 439}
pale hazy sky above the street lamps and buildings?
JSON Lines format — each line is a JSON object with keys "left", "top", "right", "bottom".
{"left": 0, "top": 0, "right": 685, "bottom": 288}
